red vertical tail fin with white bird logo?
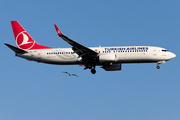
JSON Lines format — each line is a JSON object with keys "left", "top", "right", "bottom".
{"left": 11, "top": 21, "right": 51, "bottom": 50}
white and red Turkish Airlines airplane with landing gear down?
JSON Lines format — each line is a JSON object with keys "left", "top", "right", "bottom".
{"left": 4, "top": 21, "right": 176, "bottom": 74}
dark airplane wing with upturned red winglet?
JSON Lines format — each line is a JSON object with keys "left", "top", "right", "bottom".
{"left": 54, "top": 24, "right": 98, "bottom": 60}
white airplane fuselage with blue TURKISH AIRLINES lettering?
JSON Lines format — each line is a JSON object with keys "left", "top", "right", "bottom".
{"left": 16, "top": 46, "right": 176, "bottom": 65}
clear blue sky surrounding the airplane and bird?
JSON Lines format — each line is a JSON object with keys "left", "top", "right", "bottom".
{"left": 0, "top": 0, "right": 180, "bottom": 120}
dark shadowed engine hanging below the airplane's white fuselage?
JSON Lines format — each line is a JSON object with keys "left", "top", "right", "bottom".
{"left": 102, "top": 64, "right": 121, "bottom": 71}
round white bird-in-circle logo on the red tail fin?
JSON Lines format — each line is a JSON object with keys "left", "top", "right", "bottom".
{"left": 16, "top": 31, "right": 35, "bottom": 49}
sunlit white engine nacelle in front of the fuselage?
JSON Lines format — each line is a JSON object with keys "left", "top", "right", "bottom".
{"left": 99, "top": 54, "right": 116, "bottom": 62}
